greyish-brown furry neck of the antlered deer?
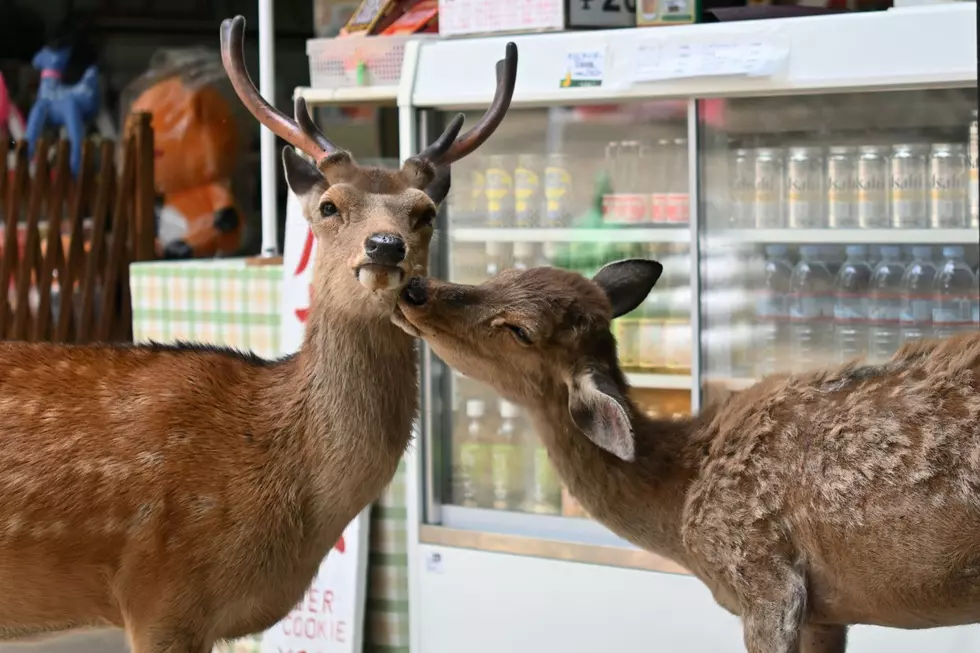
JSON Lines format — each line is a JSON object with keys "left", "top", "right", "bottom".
{"left": 279, "top": 294, "right": 418, "bottom": 524}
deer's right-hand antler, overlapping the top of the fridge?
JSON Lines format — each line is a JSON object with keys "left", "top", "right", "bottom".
{"left": 418, "top": 43, "right": 517, "bottom": 165}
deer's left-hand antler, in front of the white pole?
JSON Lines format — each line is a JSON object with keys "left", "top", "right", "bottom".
{"left": 221, "top": 16, "right": 339, "bottom": 163}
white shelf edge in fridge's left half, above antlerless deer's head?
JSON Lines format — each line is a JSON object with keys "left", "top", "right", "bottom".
{"left": 449, "top": 226, "right": 691, "bottom": 243}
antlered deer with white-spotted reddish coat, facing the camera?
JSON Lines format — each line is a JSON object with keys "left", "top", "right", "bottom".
{"left": 0, "top": 17, "right": 517, "bottom": 653}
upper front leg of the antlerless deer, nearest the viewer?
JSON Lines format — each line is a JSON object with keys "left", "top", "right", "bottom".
{"left": 742, "top": 565, "right": 806, "bottom": 653}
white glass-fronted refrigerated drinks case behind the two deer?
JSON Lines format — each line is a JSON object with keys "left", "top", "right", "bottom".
{"left": 400, "top": 5, "right": 980, "bottom": 653}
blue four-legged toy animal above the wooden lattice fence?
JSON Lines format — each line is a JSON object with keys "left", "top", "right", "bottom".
{"left": 26, "top": 47, "right": 99, "bottom": 174}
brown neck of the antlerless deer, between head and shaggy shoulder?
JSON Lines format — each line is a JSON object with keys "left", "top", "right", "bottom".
{"left": 531, "top": 393, "right": 698, "bottom": 564}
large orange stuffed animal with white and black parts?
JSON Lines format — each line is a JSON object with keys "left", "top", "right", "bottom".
{"left": 130, "top": 75, "right": 244, "bottom": 259}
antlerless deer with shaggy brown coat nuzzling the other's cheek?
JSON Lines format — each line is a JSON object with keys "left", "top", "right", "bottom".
{"left": 399, "top": 260, "right": 980, "bottom": 653}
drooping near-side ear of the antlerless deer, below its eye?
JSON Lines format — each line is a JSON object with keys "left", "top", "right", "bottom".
{"left": 568, "top": 372, "right": 636, "bottom": 462}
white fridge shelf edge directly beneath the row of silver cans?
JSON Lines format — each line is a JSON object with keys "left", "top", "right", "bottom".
{"left": 705, "top": 229, "right": 980, "bottom": 243}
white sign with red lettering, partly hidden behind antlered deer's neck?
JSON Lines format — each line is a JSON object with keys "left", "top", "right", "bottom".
{"left": 261, "top": 192, "right": 370, "bottom": 653}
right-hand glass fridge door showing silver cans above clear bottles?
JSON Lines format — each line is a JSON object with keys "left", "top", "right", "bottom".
{"left": 699, "top": 87, "right": 980, "bottom": 401}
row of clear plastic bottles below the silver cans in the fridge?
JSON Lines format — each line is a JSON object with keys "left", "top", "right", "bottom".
{"left": 755, "top": 245, "right": 980, "bottom": 375}
